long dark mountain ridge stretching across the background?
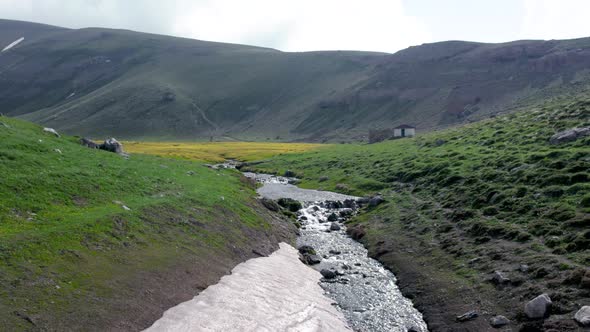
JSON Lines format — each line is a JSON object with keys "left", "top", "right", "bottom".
{"left": 0, "top": 20, "right": 590, "bottom": 141}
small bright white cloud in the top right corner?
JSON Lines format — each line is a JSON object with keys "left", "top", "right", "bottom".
{"left": 521, "top": 0, "right": 590, "bottom": 39}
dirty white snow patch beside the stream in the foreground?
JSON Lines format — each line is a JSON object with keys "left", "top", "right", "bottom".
{"left": 145, "top": 243, "right": 351, "bottom": 332}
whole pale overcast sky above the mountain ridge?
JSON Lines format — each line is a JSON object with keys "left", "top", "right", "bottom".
{"left": 0, "top": 0, "right": 590, "bottom": 52}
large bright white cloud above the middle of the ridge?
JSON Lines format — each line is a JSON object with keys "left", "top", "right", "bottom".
{"left": 175, "top": 0, "right": 431, "bottom": 52}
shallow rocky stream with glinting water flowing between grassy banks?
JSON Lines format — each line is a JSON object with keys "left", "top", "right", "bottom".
{"left": 245, "top": 173, "right": 427, "bottom": 332}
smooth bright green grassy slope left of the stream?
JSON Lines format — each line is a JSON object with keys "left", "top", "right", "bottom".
{"left": 0, "top": 117, "right": 294, "bottom": 330}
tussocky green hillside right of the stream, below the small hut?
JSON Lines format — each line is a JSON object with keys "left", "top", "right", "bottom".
{"left": 252, "top": 92, "right": 590, "bottom": 330}
